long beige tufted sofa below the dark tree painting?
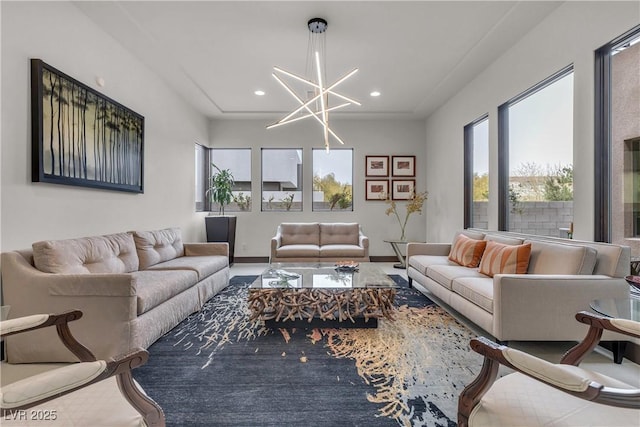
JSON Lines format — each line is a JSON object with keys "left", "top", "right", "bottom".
{"left": 2, "top": 228, "right": 229, "bottom": 363}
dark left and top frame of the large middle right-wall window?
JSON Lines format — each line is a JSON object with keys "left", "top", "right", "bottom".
{"left": 498, "top": 64, "right": 574, "bottom": 231}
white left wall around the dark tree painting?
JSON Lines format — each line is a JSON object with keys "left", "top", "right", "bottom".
{"left": 0, "top": 2, "right": 208, "bottom": 251}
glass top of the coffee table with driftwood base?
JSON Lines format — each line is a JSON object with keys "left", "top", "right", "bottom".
{"left": 251, "top": 262, "right": 397, "bottom": 289}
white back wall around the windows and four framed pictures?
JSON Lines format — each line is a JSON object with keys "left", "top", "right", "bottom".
{"left": 210, "top": 120, "right": 430, "bottom": 257}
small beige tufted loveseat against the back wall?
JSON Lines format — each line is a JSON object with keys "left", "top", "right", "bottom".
{"left": 270, "top": 222, "right": 369, "bottom": 262}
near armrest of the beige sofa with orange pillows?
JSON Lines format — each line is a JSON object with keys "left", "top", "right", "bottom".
{"left": 493, "top": 274, "right": 629, "bottom": 341}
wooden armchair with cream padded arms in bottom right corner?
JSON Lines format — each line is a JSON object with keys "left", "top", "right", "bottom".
{"left": 458, "top": 311, "right": 640, "bottom": 427}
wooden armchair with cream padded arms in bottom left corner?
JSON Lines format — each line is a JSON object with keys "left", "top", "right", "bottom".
{"left": 0, "top": 310, "right": 165, "bottom": 427}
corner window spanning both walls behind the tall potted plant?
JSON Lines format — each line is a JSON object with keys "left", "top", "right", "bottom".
{"left": 195, "top": 148, "right": 251, "bottom": 212}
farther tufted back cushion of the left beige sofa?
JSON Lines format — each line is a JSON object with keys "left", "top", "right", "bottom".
{"left": 132, "top": 228, "right": 184, "bottom": 270}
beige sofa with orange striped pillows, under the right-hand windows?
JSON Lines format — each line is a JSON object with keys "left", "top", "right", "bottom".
{"left": 407, "top": 230, "right": 630, "bottom": 341}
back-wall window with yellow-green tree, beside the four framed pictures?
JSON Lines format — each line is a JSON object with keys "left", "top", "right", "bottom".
{"left": 313, "top": 148, "right": 353, "bottom": 211}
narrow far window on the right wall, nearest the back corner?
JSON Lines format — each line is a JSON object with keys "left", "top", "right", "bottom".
{"left": 464, "top": 115, "right": 489, "bottom": 230}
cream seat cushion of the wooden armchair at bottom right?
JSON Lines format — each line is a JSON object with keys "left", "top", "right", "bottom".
{"left": 469, "top": 368, "right": 640, "bottom": 427}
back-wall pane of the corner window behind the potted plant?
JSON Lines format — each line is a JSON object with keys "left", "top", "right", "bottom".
{"left": 209, "top": 148, "right": 251, "bottom": 212}
